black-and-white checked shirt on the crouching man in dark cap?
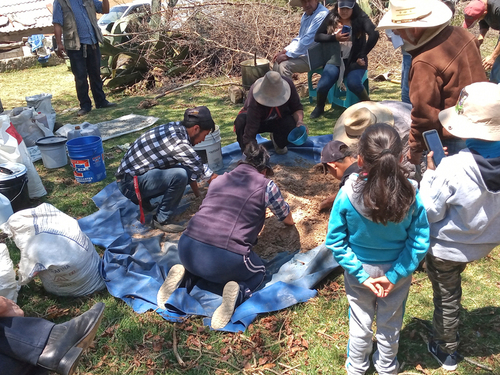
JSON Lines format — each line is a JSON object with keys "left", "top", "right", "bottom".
{"left": 115, "top": 121, "right": 213, "bottom": 181}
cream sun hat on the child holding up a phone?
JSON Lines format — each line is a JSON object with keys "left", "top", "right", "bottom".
{"left": 439, "top": 82, "right": 500, "bottom": 141}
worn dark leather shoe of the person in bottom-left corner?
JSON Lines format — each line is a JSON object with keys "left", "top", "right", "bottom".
{"left": 37, "top": 302, "right": 105, "bottom": 375}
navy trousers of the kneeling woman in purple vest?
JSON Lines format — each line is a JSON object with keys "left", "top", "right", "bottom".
{"left": 178, "top": 234, "right": 266, "bottom": 304}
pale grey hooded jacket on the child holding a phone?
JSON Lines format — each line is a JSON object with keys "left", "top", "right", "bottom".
{"left": 420, "top": 149, "right": 500, "bottom": 262}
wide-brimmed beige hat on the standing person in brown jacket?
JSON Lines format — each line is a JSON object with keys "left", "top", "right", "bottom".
{"left": 377, "top": 0, "right": 452, "bottom": 30}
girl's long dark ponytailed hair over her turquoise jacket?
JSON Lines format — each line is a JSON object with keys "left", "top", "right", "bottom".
{"left": 355, "top": 124, "right": 415, "bottom": 225}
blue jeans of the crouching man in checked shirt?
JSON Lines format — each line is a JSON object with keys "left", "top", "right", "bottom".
{"left": 117, "top": 167, "right": 190, "bottom": 224}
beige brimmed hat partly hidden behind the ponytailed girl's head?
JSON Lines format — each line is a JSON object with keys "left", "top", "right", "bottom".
{"left": 332, "top": 102, "right": 394, "bottom": 147}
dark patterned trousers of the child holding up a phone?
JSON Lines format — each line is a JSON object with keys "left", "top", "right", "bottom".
{"left": 425, "top": 253, "right": 467, "bottom": 354}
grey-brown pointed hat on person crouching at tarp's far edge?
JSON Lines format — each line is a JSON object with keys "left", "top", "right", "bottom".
{"left": 253, "top": 71, "right": 291, "bottom": 107}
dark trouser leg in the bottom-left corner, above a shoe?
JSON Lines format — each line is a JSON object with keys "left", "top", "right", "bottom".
{"left": 0, "top": 317, "right": 54, "bottom": 375}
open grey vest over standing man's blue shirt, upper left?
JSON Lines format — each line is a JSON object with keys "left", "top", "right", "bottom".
{"left": 55, "top": 0, "right": 103, "bottom": 50}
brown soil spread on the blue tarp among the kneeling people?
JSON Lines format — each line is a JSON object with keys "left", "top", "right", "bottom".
{"left": 148, "top": 165, "right": 338, "bottom": 260}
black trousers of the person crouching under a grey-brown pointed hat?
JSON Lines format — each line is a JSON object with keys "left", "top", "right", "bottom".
{"left": 234, "top": 113, "right": 297, "bottom": 151}
